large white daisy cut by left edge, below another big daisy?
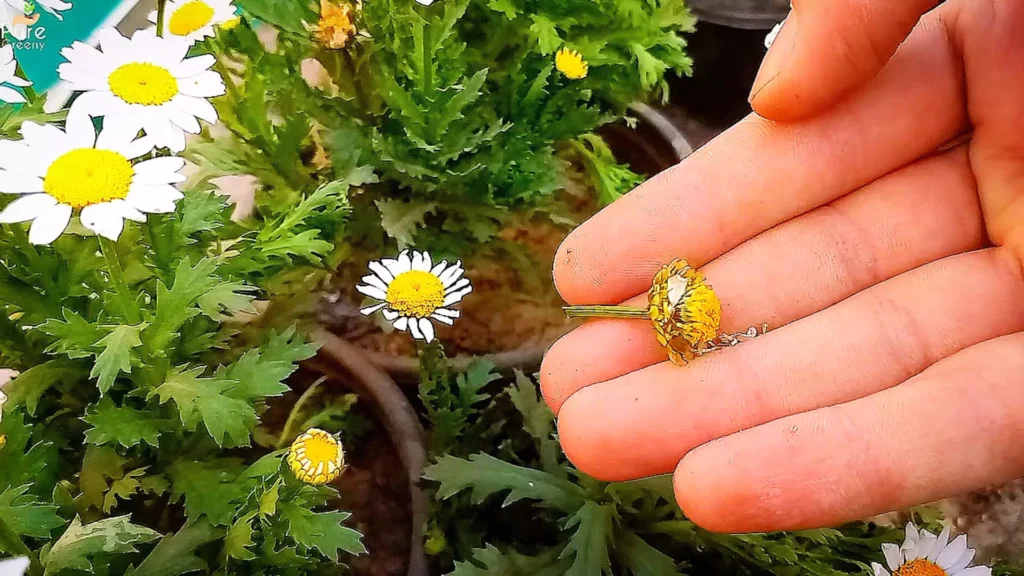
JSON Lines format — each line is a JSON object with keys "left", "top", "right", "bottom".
{"left": 0, "top": 116, "right": 185, "bottom": 244}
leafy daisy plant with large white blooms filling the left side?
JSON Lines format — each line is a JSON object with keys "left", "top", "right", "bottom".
{"left": 0, "top": 0, "right": 368, "bottom": 576}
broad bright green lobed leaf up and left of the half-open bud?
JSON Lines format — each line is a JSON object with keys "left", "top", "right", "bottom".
{"left": 150, "top": 367, "right": 257, "bottom": 446}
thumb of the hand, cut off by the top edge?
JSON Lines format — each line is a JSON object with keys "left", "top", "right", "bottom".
{"left": 750, "top": 0, "right": 938, "bottom": 122}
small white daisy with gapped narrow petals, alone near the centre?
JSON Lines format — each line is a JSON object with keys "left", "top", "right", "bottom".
{"left": 355, "top": 250, "right": 473, "bottom": 342}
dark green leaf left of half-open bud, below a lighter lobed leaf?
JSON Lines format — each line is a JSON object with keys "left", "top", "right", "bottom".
{"left": 169, "top": 459, "right": 249, "bottom": 526}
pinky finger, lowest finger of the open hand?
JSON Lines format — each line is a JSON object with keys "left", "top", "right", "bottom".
{"left": 675, "top": 333, "right": 1024, "bottom": 532}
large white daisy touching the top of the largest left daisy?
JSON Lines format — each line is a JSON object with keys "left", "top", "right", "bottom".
{"left": 57, "top": 28, "right": 224, "bottom": 152}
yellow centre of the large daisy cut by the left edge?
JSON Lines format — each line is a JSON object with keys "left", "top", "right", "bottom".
{"left": 43, "top": 148, "right": 135, "bottom": 208}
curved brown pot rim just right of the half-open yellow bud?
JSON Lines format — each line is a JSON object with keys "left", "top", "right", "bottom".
{"left": 306, "top": 330, "right": 428, "bottom": 576}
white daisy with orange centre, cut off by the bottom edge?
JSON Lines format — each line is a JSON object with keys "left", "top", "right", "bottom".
{"left": 871, "top": 524, "right": 992, "bottom": 576}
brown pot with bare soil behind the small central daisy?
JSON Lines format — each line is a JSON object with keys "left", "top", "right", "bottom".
{"left": 321, "top": 104, "right": 694, "bottom": 384}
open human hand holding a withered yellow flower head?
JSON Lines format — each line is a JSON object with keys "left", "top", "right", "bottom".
{"left": 541, "top": 0, "right": 1024, "bottom": 532}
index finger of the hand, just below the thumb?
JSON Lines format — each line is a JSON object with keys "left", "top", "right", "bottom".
{"left": 554, "top": 12, "right": 967, "bottom": 304}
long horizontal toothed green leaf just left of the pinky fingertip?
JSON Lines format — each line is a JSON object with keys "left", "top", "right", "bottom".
{"left": 423, "top": 454, "right": 584, "bottom": 512}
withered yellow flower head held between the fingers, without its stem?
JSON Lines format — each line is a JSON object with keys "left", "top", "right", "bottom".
{"left": 647, "top": 259, "right": 722, "bottom": 364}
